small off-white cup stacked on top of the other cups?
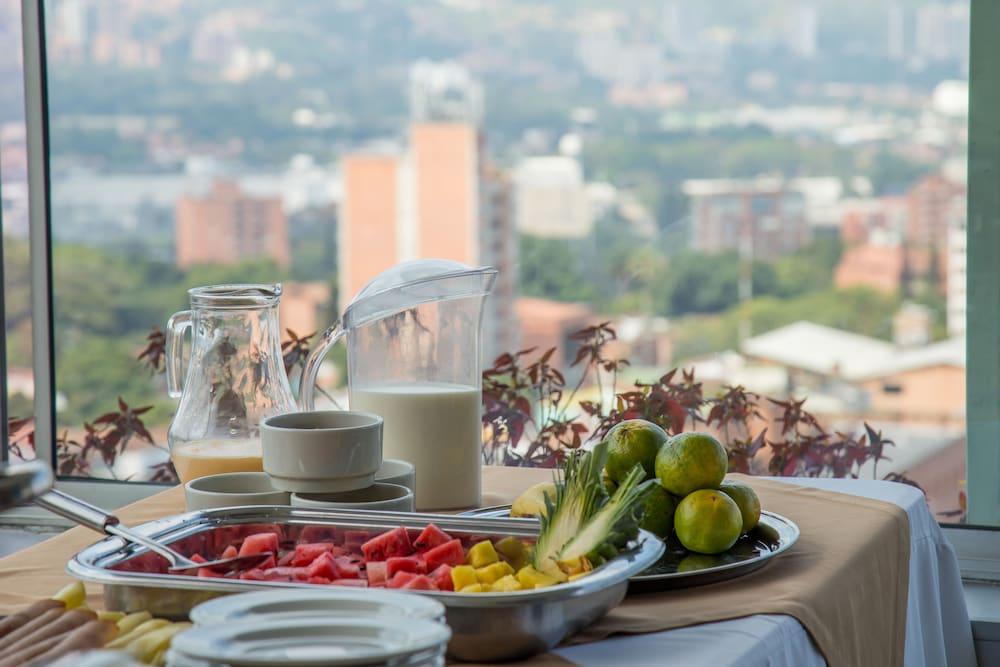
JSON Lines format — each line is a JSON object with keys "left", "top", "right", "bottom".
{"left": 260, "top": 410, "right": 382, "bottom": 493}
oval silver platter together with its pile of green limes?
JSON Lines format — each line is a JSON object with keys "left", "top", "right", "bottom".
{"left": 466, "top": 426, "right": 799, "bottom": 592}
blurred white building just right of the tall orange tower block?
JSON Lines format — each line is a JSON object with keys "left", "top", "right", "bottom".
{"left": 514, "top": 155, "right": 593, "bottom": 238}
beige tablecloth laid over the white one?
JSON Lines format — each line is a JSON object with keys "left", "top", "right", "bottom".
{"left": 0, "top": 468, "right": 910, "bottom": 667}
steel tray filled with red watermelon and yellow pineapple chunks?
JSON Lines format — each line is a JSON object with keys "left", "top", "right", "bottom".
{"left": 67, "top": 506, "right": 664, "bottom": 661}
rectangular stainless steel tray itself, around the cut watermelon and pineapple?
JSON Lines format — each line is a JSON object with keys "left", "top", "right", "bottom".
{"left": 67, "top": 506, "right": 664, "bottom": 661}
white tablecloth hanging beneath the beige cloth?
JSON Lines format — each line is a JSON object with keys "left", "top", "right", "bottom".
{"left": 556, "top": 479, "right": 976, "bottom": 667}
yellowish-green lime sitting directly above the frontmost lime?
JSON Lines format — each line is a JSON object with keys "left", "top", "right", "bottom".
{"left": 655, "top": 432, "right": 729, "bottom": 496}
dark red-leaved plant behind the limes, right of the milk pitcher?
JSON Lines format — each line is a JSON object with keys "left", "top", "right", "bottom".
{"left": 483, "top": 322, "right": 916, "bottom": 486}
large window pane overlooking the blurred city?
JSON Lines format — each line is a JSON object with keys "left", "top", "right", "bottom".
{"left": 37, "top": 0, "right": 969, "bottom": 520}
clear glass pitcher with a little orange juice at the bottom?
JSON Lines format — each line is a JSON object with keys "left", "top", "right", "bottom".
{"left": 166, "top": 284, "right": 296, "bottom": 482}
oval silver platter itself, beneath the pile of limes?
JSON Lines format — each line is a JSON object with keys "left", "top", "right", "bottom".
{"left": 463, "top": 505, "right": 799, "bottom": 593}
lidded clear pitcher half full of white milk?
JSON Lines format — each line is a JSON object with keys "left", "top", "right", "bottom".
{"left": 299, "top": 259, "right": 497, "bottom": 510}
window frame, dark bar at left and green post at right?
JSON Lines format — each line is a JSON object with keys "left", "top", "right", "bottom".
{"left": 7, "top": 0, "right": 1000, "bottom": 564}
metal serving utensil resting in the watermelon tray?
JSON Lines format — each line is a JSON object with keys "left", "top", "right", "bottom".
{"left": 35, "top": 489, "right": 276, "bottom": 574}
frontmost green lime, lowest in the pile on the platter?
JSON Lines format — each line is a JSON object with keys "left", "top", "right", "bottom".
{"left": 674, "top": 489, "right": 743, "bottom": 554}
